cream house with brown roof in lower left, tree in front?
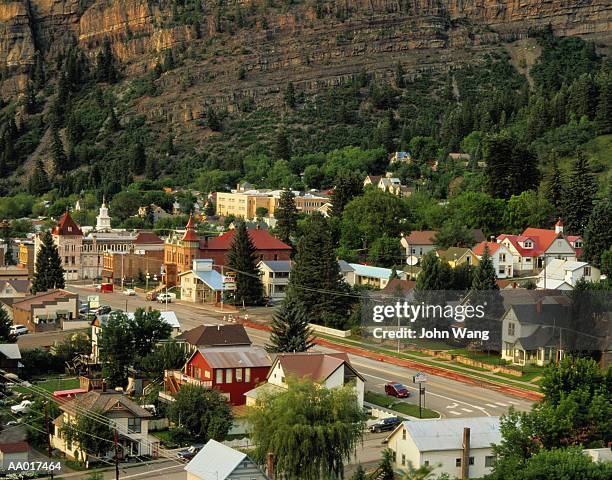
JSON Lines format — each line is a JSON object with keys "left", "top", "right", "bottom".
{"left": 51, "top": 390, "right": 159, "bottom": 461}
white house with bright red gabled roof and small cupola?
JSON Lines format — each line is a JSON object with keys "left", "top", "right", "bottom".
{"left": 497, "top": 219, "right": 582, "bottom": 274}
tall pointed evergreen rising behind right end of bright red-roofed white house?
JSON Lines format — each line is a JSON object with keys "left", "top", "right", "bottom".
{"left": 562, "top": 153, "right": 597, "bottom": 235}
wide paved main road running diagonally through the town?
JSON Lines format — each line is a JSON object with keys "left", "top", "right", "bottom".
{"left": 62, "top": 286, "right": 532, "bottom": 418}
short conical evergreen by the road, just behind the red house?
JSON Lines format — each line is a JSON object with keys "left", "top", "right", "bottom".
{"left": 266, "top": 298, "right": 314, "bottom": 353}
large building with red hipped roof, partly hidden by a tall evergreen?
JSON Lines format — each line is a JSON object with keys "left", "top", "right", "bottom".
{"left": 198, "top": 228, "right": 291, "bottom": 265}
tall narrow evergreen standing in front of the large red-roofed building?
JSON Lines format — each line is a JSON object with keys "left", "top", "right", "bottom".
{"left": 227, "top": 222, "right": 263, "bottom": 305}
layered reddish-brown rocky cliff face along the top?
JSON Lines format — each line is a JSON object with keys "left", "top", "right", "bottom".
{"left": 0, "top": 0, "right": 612, "bottom": 109}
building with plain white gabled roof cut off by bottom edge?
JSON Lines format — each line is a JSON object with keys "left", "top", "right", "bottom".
{"left": 185, "top": 440, "right": 269, "bottom": 480}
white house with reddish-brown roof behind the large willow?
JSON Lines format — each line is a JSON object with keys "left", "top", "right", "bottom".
{"left": 245, "top": 352, "right": 365, "bottom": 407}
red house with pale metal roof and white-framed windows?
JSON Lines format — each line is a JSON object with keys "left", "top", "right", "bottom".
{"left": 166, "top": 346, "right": 272, "bottom": 405}
